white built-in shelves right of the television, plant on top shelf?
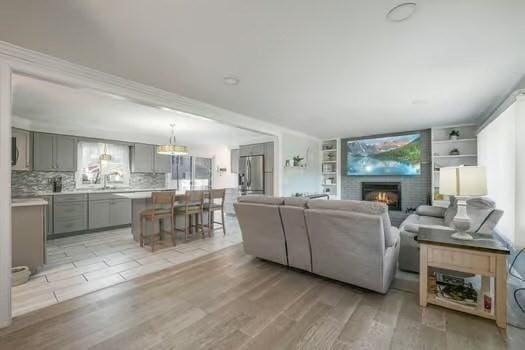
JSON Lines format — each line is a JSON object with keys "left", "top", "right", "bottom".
{"left": 432, "top": 124, "right": 478, "bottom": 207}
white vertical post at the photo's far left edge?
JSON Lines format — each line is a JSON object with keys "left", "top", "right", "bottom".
{"left": 0, "top": 62, "right": 11, "bottom": 328}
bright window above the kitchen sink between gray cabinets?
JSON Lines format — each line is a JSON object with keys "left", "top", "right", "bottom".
{"left": 76, "top": 141, "right": 130, "bottom": 188}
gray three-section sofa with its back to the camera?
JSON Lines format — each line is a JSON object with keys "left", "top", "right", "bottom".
{"left": 235, "top": 196, "right": 400, "bottom": 293}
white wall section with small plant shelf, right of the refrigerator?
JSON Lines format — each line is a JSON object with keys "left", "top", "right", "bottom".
{"left": 277, "top": 133, "right": 322, "bottom": 196}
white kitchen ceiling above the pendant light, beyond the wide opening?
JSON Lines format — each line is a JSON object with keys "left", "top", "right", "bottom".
{"left": 13, "top": 75, "right": 269, "bottom": 146}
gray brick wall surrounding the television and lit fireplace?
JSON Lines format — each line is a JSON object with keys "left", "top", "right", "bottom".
{"left": 341, "top": 129, "right": 432, "bottom": 226}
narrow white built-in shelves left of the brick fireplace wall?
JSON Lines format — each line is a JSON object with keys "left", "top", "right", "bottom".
{"left": 321, "top": 139, "right": 341, "bottom": 198}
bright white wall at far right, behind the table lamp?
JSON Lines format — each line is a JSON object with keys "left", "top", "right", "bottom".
{"left": 478, "top": 100, "right": 525, "bottom": 246}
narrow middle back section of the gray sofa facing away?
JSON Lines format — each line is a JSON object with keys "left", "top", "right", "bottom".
{"left": 279, "top": 206, "right": 312, "bottom": 272}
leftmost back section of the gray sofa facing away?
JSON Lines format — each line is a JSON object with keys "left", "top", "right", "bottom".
{"left": 234, "top": 201, "right": 288, "bottom": 265}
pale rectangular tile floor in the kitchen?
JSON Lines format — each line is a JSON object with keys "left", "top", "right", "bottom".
{"left": 12, "top": 216, "right": 242, "bottom": 316}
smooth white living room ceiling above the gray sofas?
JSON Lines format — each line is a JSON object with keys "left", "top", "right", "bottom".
{"left": 0, "top": 0, "right": 525, "bottom": 137}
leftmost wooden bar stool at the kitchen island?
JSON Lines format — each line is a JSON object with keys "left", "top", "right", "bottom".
{"left": 140, "top": 192, "right": 176, "bottom": 251}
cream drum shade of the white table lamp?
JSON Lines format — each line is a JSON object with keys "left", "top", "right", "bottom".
{"left": 439, "top": 166, "right": 487, "bottom": 196}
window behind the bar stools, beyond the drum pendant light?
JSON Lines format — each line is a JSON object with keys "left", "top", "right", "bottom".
{"left": 171, "top": 156, "right": 213, "bottom": 191}
